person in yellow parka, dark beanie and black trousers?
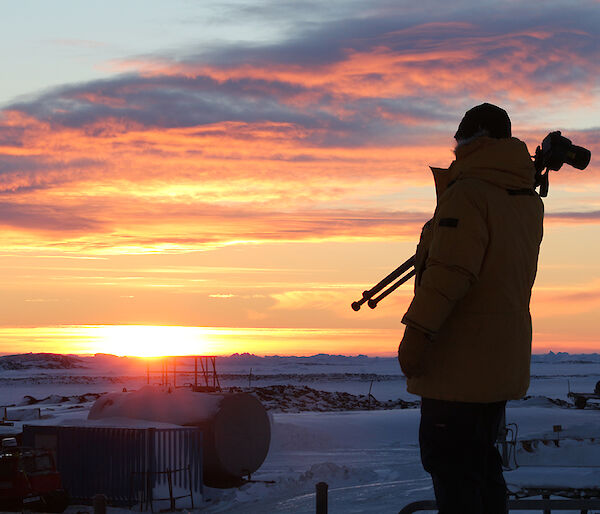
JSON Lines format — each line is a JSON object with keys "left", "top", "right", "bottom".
{"left": 398, "top": 103, "right": 543, "bottom": 514}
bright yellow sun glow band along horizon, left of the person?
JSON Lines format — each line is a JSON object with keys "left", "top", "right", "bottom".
{"left": 0, "top": 325, "right": 408, "bottom": 357}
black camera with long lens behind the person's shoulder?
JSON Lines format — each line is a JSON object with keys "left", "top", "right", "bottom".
{"left": 534, "top": 130, "right": 592, "bottom": 197}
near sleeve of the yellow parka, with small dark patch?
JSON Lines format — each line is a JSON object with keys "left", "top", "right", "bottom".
{"left": 402, "top": 180, "right": 489, "bottom": 335}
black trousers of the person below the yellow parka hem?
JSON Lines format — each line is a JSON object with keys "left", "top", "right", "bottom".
{"left": 419, "top": 398, "right": 507, "bottom": 514}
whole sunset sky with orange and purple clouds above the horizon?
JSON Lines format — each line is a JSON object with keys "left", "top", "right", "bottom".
{"left": 0, "top": 0, "right": 600, "bottom": 355}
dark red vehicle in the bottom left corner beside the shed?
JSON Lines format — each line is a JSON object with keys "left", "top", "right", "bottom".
{"left": 0, "top": 446, "right": 69, "bottom": 512}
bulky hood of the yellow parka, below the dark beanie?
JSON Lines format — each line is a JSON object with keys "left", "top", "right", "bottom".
{"left": 431, "top": 136, "right": 535, "bottom": 199}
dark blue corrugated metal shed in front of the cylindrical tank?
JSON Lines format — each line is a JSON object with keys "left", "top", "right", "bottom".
{"left": 23, "top": 425, "right": 202, "bottom": 507}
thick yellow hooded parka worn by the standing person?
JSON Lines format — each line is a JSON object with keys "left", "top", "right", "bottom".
{"left": 402, "top": 137, "right": 544, "bottom": 403}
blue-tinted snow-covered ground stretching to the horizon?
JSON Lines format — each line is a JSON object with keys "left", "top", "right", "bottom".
{"left": 0, "top": 354, "right": 600, "bottom": 513}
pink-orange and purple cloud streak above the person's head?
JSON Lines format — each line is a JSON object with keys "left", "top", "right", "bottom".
{"left": 118, "top": 22, "right": 600, "bottom": 111}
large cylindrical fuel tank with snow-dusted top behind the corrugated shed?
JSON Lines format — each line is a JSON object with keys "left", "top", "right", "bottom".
{"left": 88, "top": 386, "right": 271, "bottom": 488}
